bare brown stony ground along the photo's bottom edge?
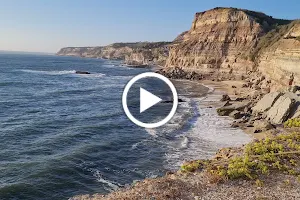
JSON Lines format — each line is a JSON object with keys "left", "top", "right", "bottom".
{"left": 70, "top": 173, "right": 300, "bottom": 200}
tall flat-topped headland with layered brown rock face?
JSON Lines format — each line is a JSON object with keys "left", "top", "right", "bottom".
{"left": 166, "top": 8, "right": 290, "bottom": 79}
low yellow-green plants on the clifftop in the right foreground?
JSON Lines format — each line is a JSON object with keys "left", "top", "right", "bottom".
{"left": 181, "top": 132, "right": 300, "bottom": 182}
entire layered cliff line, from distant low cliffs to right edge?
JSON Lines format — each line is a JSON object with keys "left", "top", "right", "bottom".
{"left": 57, "top": 7, "right": 300, "bottom": 88}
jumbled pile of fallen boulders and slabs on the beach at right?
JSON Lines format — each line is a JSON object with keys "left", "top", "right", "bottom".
{"left": 224, "top": 87, "right": 300, "bottom": 133}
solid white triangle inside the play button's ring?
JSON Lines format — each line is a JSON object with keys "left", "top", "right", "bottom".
{"left": 140, "top": 88, "right": 162, "bottom": 113}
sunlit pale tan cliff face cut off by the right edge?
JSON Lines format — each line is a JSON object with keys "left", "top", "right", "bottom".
{"left": 257, "top": 21, "right": 300, "bottom": 86}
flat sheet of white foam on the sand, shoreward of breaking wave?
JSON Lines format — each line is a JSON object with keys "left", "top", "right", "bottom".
{"left": 166, "top": 96, "right": 252, "bottom": 170}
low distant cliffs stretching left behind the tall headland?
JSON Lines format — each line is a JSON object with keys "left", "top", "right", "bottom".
{"left": 57, "top": 42, "right": 169, "bottom": 65}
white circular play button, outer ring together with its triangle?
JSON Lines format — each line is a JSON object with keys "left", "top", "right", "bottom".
{"left": 122, "top": 72, "right": 178, "bottom": 128}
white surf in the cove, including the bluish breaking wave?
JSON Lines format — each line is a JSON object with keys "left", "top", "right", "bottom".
{"left": 135, "top": 80, "right": 252, "bottom": 170}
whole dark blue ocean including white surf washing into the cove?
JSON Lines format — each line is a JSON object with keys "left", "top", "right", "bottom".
{"left": 0, "top": 53, "right": 251, "bottom": 200}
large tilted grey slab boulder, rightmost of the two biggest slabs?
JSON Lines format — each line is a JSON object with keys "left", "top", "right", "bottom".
{"left": 267, "top": 93, "right": 296, "bottom": 124}
